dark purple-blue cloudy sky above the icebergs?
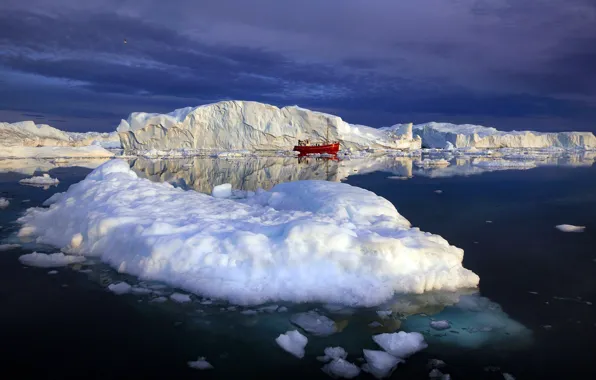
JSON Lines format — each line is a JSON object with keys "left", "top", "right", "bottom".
{"left": 0, "top": 0, "right": 596, "bottom": 132}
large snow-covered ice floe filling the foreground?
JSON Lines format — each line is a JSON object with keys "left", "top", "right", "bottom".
{"left": 19, "top": 160, "right": 479, "bottom": 306}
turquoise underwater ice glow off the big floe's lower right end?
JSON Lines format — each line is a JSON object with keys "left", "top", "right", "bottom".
{"left": 401, "top": 294, "right": 532, "bottom": 349}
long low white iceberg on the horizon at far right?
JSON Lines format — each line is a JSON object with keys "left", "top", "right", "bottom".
{"left": 381, "top": 122, "right": 596, "bottom": 149}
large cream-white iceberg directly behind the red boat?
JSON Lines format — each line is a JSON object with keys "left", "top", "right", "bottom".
{"left": 117, "top": 101, "right": 420, "bottom": 151}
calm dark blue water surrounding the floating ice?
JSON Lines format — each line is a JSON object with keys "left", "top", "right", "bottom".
{"left": 0, "top": 157, "right": 596, "bottom": 379}
